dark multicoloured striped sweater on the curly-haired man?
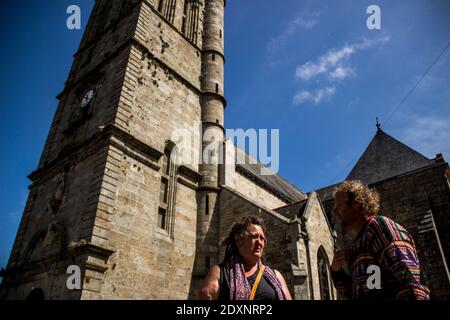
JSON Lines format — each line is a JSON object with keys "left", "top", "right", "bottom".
{"left": 331, "top": 216, "right": 429, "bottom": 300}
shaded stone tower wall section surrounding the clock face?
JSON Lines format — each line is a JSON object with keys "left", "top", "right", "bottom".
{"left": 39, "top": 3, "right": 139, "bottom": 168}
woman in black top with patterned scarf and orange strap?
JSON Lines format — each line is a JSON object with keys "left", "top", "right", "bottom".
{"left": 199, "top": 216, "right": 292, "bottom": 300}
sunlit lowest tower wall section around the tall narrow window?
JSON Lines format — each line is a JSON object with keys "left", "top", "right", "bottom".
{"left": 78, "top": 141, "right": 197, "bottom": 299}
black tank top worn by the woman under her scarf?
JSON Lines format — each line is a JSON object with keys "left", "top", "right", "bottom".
{"left": 219, "top": 263, "right": 277, "bottom": 300}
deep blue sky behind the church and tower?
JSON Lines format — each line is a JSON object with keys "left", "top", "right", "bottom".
{"left": 0, "top": 0, "right": 450, "bottom": 267}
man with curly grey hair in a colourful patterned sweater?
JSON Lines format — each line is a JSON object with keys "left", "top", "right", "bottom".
{"left": 331, "top": 181, "right": 429, "bottom": 300}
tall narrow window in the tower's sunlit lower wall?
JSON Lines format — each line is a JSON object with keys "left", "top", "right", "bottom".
{"left": 157, "top": 142, "right": 177, "bottom": 235}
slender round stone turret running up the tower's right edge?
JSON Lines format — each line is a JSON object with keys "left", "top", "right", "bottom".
{"left": 191, "top": 0, "right": 226, "bottom": 294}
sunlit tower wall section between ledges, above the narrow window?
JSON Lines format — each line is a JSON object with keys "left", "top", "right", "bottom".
{"left": 119, "top": 46, "right": 201, "bottom": 171}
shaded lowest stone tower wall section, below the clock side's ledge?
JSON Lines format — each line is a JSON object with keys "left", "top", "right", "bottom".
{"left": 1, "top": 137, "right": 111, "bottom": 299}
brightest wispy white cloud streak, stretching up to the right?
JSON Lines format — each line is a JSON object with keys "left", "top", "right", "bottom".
{"left": 295, "top": 37, "right": 390, "bottom": 80}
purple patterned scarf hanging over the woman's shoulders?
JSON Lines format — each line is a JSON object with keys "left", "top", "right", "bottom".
{"left": 226, "top": 255, "right": 285, "bottom": 300}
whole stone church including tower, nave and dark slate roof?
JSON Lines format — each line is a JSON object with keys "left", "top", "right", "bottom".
{"left": 0, "top": 0, "right": 450, "bottom": 300}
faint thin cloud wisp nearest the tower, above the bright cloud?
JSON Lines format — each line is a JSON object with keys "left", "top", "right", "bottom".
{"left": 268, "top": 11, "right": 319, "bottom": 51}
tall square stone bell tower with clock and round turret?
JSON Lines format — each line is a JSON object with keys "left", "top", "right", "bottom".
{"left": 0, "top": 0, "right": 225, "bottom": 299}
